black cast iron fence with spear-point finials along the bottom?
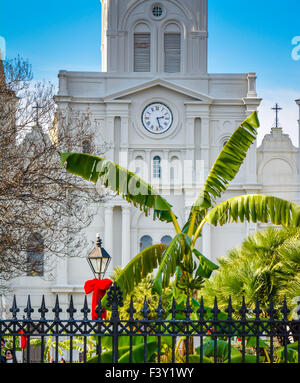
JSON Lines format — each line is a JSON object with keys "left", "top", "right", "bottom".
{"left": 0, "top": 284, "right": 300, "bottom": 363}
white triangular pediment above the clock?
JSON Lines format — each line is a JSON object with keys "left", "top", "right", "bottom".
{"left": 104, "top": 79, "right": 214, "bottom": 104}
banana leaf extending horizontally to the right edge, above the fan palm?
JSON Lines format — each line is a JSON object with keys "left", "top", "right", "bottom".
{"left": 205, "top": 194, "right": 300, "bottom": 227}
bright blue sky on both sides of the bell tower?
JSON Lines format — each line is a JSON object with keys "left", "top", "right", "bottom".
{"left": 0, "top": 0, "right": 300, "bottom": 144}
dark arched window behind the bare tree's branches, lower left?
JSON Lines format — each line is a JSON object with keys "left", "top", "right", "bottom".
{"left": 27, "top": 233, "right": 44, "bottom": 277}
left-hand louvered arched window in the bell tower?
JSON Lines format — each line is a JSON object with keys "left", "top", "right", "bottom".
{"left": 133, "top": 23, "right": 151, "bottom": 72}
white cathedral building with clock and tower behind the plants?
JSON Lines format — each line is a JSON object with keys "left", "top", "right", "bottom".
{"left": 3, "top": 0, "right": 300, "bottom": 316}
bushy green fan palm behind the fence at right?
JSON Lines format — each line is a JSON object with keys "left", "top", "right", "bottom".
{"left": 201, "top": 228, "right": 300, "bottom": 317}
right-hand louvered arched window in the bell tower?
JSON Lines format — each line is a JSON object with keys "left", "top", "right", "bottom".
{"left": 164, "top": 24, "right": 181, "bottom": 73}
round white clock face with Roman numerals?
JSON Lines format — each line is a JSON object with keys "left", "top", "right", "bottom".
{"left": 142, "top": 102, "right": 173, "bottom": 134}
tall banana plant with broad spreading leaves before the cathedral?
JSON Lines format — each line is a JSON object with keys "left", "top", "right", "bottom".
{"left": 61, "top": 112, "right": 300, "bottom": 296}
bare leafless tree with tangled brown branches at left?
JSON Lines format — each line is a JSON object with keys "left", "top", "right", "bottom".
{"left": 0, "top": 58, "right": 109, "bottom": 288}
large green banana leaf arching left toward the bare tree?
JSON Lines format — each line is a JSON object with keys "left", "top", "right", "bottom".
{"left": 60, "top": 153, "right": 172, "bottom": 222}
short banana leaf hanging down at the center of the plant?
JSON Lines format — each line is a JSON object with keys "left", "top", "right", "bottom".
{"left": 153, "top": 233, "right": 191, "bottom": 295}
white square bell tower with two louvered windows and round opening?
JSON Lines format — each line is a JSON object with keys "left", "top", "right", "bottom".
{"left": 101, "top": 0, "right": 208, "bottom": 76}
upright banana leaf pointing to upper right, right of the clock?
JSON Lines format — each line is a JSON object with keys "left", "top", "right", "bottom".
{"left": 183, "top": 112, "right": 259, "bottom": 231}
